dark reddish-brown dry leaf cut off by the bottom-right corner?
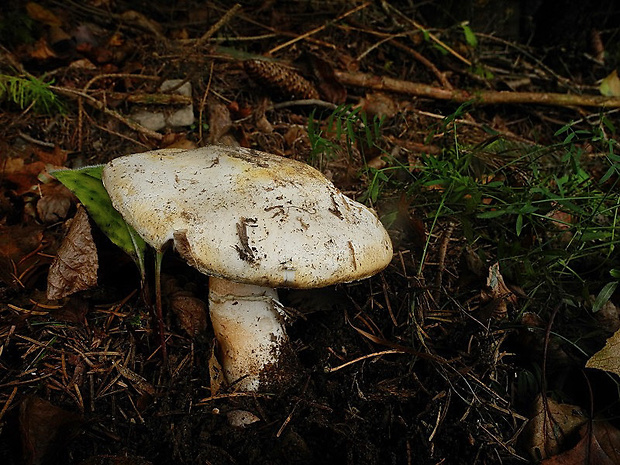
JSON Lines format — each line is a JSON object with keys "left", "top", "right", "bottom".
{"left": 541, "top": 422, "right": 620, "bottom": 465}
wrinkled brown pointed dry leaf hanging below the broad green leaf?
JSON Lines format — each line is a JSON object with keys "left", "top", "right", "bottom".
{"left": 47, "top": 207, "right": 99, "bottom": 300}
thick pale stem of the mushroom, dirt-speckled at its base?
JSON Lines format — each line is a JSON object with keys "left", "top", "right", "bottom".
{"left": 209, "top": 277, "right": 287, "bottom": 391}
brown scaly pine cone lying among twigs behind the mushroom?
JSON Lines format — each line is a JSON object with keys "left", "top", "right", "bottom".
{"left": 243, "top": 60, "right": 319, "bottom": 99}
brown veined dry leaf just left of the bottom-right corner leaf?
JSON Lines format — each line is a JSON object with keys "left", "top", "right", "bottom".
{"left": 524, "top": 395, "right": 587, "bottom": 460}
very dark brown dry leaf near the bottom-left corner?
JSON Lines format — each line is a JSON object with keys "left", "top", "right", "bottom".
{"left": 19, "top": 396, "right": 81, "bottom": 465}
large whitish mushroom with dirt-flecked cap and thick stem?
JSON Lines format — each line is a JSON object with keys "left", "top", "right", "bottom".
{"left": 102, "top": 145, "right": 392, "bottom": 391}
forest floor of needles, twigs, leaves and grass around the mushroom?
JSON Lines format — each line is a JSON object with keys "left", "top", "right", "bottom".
{"left": 0, "top": 0, "right": 620, "bottom": 465}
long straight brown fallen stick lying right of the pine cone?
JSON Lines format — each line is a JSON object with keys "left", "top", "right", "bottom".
{"left": 335, "top": 71, "right": 620, "bottom": 108}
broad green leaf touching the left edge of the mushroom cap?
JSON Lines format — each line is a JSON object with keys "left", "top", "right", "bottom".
{"left": 51, "top": 165, "right": 146, "bottom": 272}
